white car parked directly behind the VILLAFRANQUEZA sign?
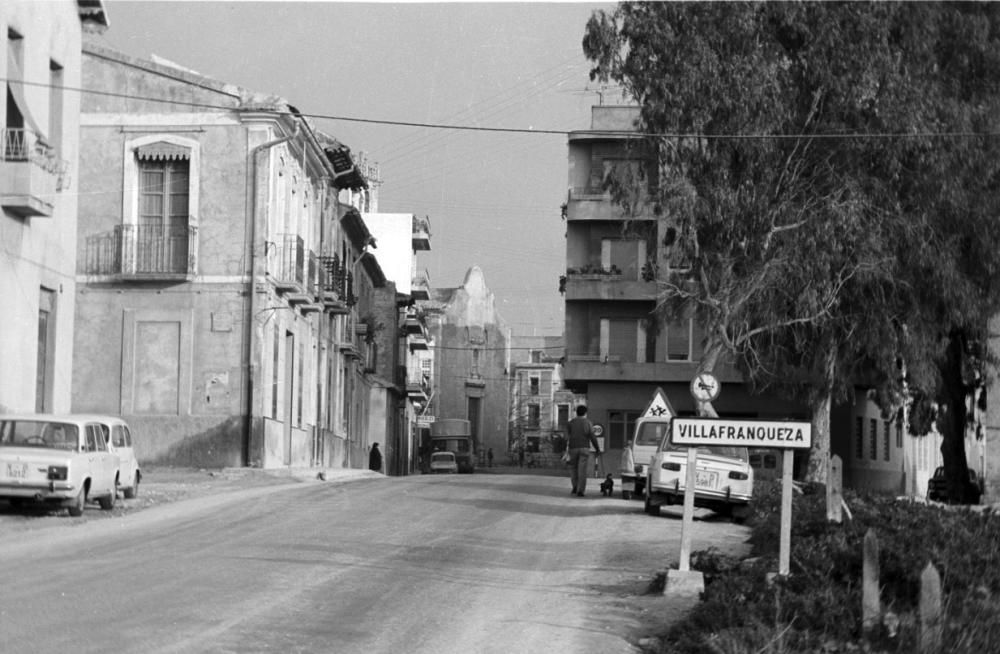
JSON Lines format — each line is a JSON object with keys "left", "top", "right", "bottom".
{"left": 646, "top": 435, "right": 753, "bottom": 523}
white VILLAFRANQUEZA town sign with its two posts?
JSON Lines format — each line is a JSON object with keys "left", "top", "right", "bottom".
{"left": 667, "top": 416, "right": 812, "bottom": 596}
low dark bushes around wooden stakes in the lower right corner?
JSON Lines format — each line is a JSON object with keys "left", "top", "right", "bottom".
{"left": 662, "top": 482, "right": 1000, "bottom": 654}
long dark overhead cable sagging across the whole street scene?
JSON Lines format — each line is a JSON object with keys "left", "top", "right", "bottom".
{"left": 7, "top": 77, "right": 1000, "bottom": 140}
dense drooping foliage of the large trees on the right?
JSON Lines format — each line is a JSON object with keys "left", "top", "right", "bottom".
{"left": 583, "top": 2, "right": 1000, "bottom": 492}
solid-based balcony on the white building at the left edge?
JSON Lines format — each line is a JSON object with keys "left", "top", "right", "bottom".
{"left": 0, "top": 128, "right": 69, "bottom": 218}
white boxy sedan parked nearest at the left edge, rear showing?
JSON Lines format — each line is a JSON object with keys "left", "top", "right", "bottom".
{"left": 0, "top": 414, "right": 119, "bottom": 516}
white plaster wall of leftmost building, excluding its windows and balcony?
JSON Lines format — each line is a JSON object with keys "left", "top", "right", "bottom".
{"left": 0, "top": 0, "right": 81, "bottom": 412}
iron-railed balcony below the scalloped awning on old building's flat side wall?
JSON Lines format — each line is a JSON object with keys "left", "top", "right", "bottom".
{"left": 84, "top": 225, "right": 197, "bottom": 281}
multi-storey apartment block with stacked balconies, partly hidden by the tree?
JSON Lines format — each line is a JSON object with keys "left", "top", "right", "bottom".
{"left": 562, "top": 106, "right": 802, "bottom": 460}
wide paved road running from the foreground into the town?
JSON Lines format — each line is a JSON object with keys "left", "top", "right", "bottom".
{"left": 0, "top": 474, "right": 747, "bottom": 654}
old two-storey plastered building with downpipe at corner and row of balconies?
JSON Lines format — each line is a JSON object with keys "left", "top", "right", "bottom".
{"left": 73, "top": 43, "right": 385, "bottom": 467}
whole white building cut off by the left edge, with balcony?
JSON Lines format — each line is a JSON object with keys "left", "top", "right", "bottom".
{"left": 0, "top": 0, "right": 108, "bottom": 412}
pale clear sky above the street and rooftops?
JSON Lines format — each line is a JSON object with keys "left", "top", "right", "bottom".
{"left": 95, "top": 0, "right": 612, "bottom": 337}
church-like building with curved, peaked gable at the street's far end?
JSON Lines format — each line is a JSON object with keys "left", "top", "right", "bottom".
{"left": 422, "top": 266, "right": 510, "bottom": 460}
